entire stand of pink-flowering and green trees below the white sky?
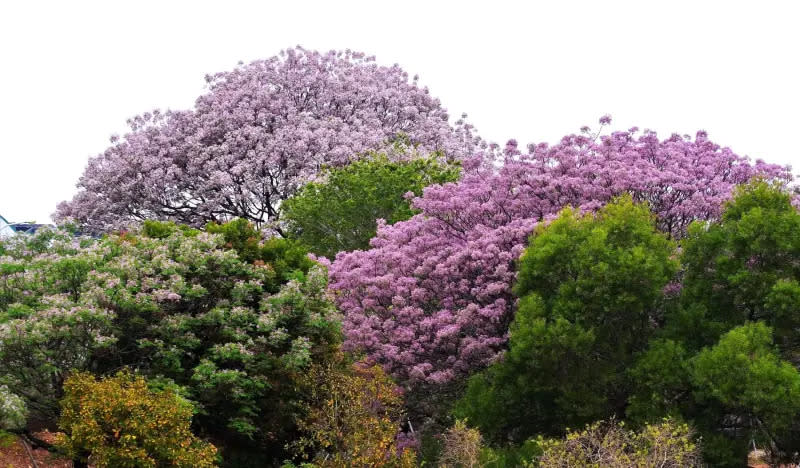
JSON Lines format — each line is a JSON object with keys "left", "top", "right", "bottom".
{"left": 0, "top": 49, "right": 800, "bottom": 466}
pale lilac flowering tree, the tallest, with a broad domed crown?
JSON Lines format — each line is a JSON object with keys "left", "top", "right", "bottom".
{"left": 55, "top": 47, "right": 476, "bottom": 231}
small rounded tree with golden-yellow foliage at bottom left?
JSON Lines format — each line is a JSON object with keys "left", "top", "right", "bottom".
{"left": 56, "top": 372, "right": 217, "bottom": 468}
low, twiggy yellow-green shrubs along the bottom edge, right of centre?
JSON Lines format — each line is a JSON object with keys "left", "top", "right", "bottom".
{"left": 531, "top": 419, "right": 701, "bottom": 468}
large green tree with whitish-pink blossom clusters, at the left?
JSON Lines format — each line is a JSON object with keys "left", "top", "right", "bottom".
{"left": 0, "top": 223, "right": 339, "bottom": 462}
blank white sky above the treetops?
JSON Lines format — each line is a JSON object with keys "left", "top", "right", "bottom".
{"left": 0, "top": 0, "right": 800, "bottom": 222}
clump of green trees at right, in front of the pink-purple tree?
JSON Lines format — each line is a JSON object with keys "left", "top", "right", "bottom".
{"left": 455, "top": 182, "right": 800, "bottom": 466}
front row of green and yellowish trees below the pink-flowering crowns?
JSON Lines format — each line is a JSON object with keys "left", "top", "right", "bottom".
{"left": 0, "top": 181, "right": 800, "bottom": 466}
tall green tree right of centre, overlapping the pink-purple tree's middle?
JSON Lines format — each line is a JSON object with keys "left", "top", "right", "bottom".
{"left": 456, "top": 197, "right": 677, "bottom": 442}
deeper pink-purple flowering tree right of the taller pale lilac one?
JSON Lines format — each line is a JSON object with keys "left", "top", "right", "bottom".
{"left": 330, "top": 117, "right": 791, "bottom": 388}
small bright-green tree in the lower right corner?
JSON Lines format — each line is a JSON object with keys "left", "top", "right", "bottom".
{"left": 689, "top": 322, "right": 800, "bottom": 466}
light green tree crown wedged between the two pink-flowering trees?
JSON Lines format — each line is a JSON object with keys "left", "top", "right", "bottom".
{"left": 282, "top": 153, "right": 459, "bottom": 258}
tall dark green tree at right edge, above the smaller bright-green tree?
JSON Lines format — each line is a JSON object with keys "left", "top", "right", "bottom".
{"left": 670, "top": 182, "right": 800, "bottom": 358}
